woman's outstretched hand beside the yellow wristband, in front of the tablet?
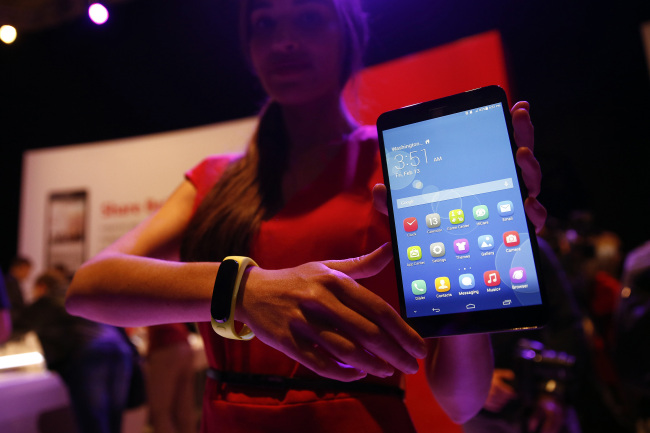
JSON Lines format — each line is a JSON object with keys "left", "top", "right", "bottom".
{"left": 235, "top": 244, "right": 427, "bottom": 381}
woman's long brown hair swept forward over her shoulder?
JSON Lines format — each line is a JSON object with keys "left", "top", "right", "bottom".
{"left": 181, "top": 0, "right": 367, "bottom": 262}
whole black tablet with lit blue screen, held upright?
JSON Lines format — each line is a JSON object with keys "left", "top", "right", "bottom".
{"left": 377, "top": 86, "right": 547, "bottom": 337}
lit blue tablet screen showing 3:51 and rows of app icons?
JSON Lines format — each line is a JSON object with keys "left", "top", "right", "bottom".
{"left": 382, "top": 103, "right": 541, "bottom": 317}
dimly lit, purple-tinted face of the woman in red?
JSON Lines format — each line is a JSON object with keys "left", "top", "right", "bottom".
{"left": 249, "top": 0, "right": 342, "bottom": 105}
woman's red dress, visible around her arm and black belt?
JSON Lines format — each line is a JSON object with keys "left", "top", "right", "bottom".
{"left": 187, "top": 127, "right": 415, "bottom": 433}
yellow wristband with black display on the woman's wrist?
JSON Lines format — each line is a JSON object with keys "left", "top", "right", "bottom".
{"left": 210, "top": 256, "right": 257, "bottom": 340}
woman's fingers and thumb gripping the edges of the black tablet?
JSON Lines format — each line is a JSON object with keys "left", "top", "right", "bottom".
{"left": 372, "top": 101, "right": 547, "bottom": 233}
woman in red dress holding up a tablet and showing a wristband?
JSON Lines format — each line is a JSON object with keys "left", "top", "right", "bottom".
{"left": 68, "top": 0, "right": 545, "bottom": 432}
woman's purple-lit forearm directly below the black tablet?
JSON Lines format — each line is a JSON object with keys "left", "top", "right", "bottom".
{"left": 427, "top": 334, "right": 494, "bottom": 424}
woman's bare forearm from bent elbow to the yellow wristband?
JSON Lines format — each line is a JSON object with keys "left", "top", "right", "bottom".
{"left": 66, "top": 253, "right": 219, "bottom": 326}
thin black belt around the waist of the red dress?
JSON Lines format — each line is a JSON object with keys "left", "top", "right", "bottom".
{"left": 207, "top": 368, "right": 404, "bottom": 399}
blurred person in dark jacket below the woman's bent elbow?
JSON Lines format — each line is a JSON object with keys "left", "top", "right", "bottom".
{"left": 14, "top": 269, "right": 133, "bottom": 433}
